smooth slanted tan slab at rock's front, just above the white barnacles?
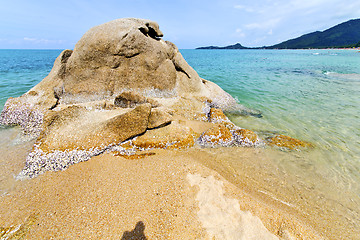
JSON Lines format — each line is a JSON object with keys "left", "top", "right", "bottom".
{"left": 37, "top": 103, "right": 151, "bottom": 152}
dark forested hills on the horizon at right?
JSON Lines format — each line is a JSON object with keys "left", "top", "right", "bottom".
{"left": 196, "top": 19, "right": 360, "bottom": 49}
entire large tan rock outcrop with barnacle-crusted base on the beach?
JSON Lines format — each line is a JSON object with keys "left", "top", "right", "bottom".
{"left": 0, "top": 18, "right": 310, "bottom": 177}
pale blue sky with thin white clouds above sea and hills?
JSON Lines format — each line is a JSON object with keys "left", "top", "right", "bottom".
{"left": 0, "top": 0, "right": 360, "bottom": 49}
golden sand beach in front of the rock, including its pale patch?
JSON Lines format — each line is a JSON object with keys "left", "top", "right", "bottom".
{"left": 0, "top": 126, "right": 321, "bottom": 239}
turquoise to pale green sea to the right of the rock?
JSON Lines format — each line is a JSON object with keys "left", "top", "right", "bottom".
{"left": 182, "top": 50, "right": 360, "bottom": 195}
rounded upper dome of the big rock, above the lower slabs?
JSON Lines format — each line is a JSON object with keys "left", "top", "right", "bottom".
{"left": 28, "top": 18, "right": 234, "bottom": 107}
